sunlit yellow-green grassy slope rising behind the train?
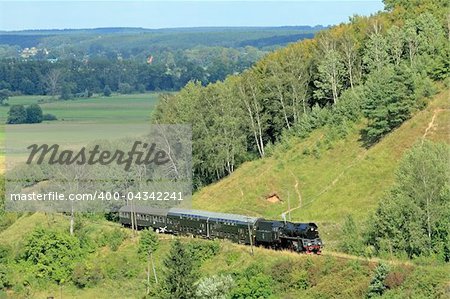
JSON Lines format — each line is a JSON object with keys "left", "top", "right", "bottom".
{"left": 194, "top": 91, "right": 450, "bottom": 246}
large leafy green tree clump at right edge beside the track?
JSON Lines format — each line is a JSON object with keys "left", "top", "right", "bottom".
{"left": 368, "top": 141, "right": 450, "bottom": 261}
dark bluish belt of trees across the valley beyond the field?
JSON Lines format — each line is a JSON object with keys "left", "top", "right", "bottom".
{"left": 0, "top": 47, "right": 262, "bottom": 99}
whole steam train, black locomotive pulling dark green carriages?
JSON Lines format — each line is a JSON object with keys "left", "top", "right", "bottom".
{"left": 119, "top": 206, "right": 323, "bottom": 254}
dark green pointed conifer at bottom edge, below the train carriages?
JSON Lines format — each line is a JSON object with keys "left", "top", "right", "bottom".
{"left": 162, "top": 239, "right": 197, "bottom": 299}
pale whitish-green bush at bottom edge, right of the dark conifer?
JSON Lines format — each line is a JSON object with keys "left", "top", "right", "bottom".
{"left": 195, "top": 275, "right": 235, "bottom": 299}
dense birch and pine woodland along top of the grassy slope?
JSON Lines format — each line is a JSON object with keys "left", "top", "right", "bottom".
{"left": 153, "top": 1, "right": 449, "bottom": 188}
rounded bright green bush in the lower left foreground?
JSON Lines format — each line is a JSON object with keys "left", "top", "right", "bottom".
{"left": 22, "top": 228, "right": 83, "bottom": 283}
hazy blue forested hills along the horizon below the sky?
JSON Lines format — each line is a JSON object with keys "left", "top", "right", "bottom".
{"left": 0, "top": 25, "right": 324, "bottom": 56}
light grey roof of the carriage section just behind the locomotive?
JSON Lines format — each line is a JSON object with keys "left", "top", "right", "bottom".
{"left": 167, "top": 208, "right": 260, "bottom": 225}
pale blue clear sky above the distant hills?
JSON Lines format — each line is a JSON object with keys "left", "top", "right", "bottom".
{"left": 0, "top": 0, "right": 383, "bottom": 30}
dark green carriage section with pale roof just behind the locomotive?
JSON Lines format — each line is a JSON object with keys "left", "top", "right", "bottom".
{"left": 167, "top": 208, "right": 259, "bottom": 244}
